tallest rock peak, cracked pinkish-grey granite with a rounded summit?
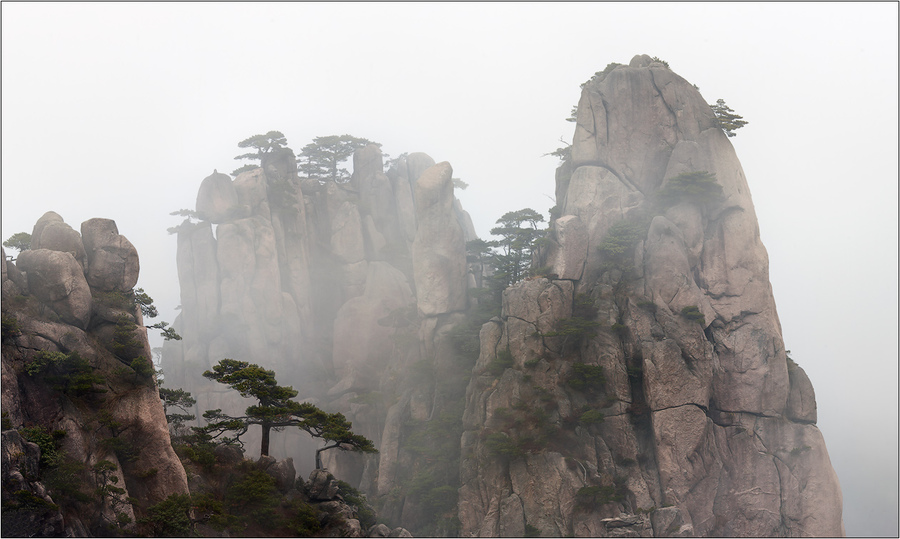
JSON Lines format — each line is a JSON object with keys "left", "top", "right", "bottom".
{"left": 459, "top": 56, "right": 843, "bottom": 536}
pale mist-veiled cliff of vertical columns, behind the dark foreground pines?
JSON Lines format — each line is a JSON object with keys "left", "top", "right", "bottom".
{"left": 163, "top": 145, "right": 475, "bottom": 530}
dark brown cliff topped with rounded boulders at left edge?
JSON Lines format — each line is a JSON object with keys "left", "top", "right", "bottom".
{"left": 0, "top": 212, "right": 187, "bottom": 536}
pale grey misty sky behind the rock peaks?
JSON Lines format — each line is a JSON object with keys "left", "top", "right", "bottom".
{"left": 0, "top": 2, "right": 898, "bottom": 536}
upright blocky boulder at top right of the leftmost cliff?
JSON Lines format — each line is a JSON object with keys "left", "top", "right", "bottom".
{"left": 81, "top": 218, "right": 141, "bottom": 292}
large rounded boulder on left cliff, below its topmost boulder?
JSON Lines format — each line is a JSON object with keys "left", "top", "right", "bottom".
{"left": 17, "top": 249, "right": 93, "bottom": 329}
